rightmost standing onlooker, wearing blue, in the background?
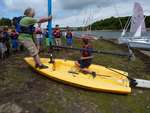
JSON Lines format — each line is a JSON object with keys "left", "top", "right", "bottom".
{"left": 66, "top": 27, "right": 73, "bottom": 47}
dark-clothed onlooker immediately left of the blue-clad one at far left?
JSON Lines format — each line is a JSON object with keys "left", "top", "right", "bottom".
{"left": 3, "top": 27, "right": 10, "bottom": 57}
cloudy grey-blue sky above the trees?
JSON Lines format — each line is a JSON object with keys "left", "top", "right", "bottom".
{"left": 0, "top": 0, "right": 150, "bottom": 26}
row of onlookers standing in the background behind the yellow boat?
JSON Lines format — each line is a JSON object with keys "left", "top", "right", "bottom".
{"left": 0, "top": 23, "right": 73, "bottom": 59}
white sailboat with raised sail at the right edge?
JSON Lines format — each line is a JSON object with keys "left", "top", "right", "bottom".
{"left": 118, "top": 2, "right": 150, "bottom": 50}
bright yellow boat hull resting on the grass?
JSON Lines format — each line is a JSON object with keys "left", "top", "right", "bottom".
{"left": 25, "top": 57, "right": 131, "bottom": 94}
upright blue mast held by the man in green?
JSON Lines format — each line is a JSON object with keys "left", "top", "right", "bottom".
{"left": 48, "top": 0, "right": 53, "bottom": 46}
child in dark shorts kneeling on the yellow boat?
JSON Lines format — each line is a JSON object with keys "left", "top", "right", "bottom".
{"left": 75, "top": 38, "right": 96, "bottom": 78}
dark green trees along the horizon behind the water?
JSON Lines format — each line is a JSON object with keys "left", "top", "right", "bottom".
{"left": 0, "top": 16, "right": 150, "bottom": 30}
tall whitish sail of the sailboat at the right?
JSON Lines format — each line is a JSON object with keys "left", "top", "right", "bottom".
{"left": 130, "top": 2, "right": 146, "bottom": 34}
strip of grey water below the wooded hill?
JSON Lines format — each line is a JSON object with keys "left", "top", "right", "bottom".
{"left": 74, "top": 31, "right": 150, "bottom": 39}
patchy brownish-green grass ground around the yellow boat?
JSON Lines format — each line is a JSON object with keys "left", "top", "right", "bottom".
{"left": 0, "top": 40, "right": 150, "bottom": 113}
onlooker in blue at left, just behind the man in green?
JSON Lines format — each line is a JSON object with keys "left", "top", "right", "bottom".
{"left": 10, "top": 29, "right": 18, "bottom": 52}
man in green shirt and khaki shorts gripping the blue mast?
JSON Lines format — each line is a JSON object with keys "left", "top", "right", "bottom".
{"left": 19, "top": 8, "right": 52, "bottom": 69}
